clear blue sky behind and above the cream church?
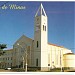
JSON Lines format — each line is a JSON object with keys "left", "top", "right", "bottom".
{"left": 0, "top": 1, "right": 75, "bottom": 53}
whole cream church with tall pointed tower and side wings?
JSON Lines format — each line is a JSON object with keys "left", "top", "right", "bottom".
{"left": 0, "top": 4, "right": 75, "bottom": 71}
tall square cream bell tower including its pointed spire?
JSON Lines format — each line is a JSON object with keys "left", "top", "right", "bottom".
{"left": 34, "top": 4, "right": 48, "bottom": 71}
